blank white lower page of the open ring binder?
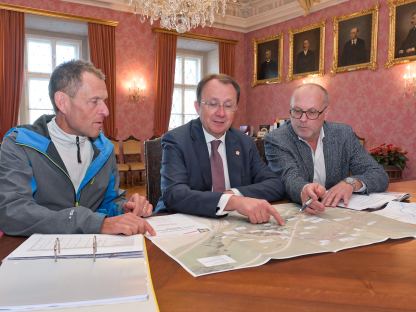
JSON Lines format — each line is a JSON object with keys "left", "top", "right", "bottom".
{"left": 0, "top": 258, "right": 148, "bottom": 311}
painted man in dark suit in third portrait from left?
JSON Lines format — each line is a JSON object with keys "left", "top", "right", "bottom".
{"left": 340, "top": 27, "right": 370, "bottom": 66}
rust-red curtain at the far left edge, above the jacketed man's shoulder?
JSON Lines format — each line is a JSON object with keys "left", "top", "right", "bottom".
{"left": 0, "top": 9, "right": 25, "bottom": 142}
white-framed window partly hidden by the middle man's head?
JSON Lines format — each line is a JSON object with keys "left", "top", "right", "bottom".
{"left": 169, "top": 53, "right": 203, "bottom": 130}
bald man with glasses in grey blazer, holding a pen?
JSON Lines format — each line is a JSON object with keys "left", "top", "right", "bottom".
{"left": 265, "top": 83, "right": 388, "bottom": 214}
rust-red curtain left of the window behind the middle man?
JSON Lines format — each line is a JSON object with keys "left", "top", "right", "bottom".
{"left": 153, "top": 32, "right": 177, "bottom": 137}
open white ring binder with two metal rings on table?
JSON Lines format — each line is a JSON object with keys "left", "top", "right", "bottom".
{"left": 0, "top": 234, "right": 158, "bottom": 311}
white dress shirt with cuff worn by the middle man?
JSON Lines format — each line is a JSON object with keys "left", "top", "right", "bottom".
{"left": 202, "top": 127, "right": 242, "bottom": 216}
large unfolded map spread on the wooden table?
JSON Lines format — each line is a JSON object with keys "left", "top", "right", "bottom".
{"left": 147, "top": 204, "right": 416, "bottom": 276}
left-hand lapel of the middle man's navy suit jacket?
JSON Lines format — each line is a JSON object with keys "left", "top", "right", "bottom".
{"left": 191, "top": 118, "right": 212, "bottom": 189}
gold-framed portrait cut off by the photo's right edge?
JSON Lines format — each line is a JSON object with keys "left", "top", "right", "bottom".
{"left": 385, "top": 0, "right": 416, "bottom": 68}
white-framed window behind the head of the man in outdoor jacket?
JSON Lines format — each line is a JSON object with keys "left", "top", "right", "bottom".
{"left": 20, "top": 34, "right": 82, "bottom": 124}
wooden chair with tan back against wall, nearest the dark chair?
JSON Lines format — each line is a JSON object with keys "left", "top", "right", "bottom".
{"left": 122, "top": 136, "right": 145, "bottom": 185}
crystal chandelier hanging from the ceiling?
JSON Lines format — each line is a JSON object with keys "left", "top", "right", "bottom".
{"left": 129, "top": 0, "right": 232, "bottom": 33}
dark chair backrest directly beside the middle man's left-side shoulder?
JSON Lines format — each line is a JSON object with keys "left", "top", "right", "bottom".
{"left": 144, "top": 138, "right": 162, "bottom": 207}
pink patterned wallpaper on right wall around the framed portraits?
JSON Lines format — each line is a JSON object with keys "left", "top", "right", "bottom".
{"left": 245, "top": 0, "right": 416, "bottom": 179}
